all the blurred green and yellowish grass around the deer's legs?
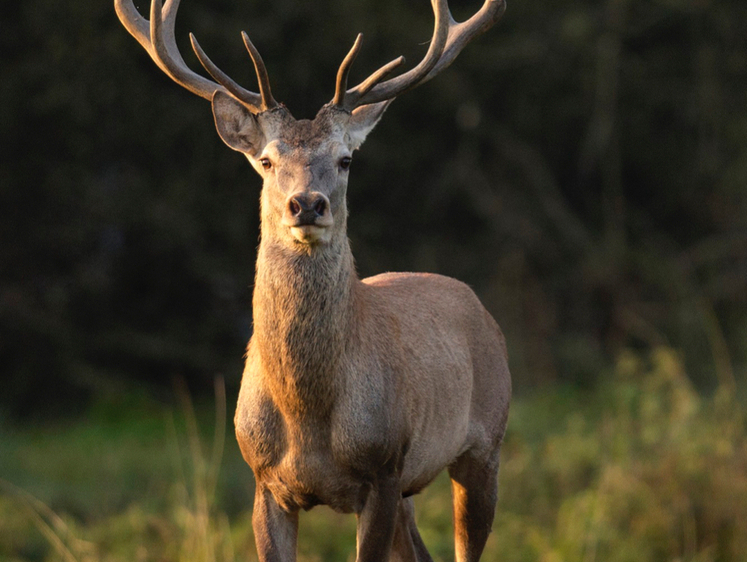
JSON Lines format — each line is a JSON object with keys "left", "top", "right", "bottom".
{"left": 0, "top": 348, "right": 747, "bottom": 562}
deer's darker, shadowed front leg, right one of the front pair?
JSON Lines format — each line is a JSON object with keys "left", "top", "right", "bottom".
{"left": 356, "top": 475, "right": 402, "bottom": 562}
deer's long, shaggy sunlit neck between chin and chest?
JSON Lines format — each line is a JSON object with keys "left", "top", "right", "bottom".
{"left": 253, "top": 236, "right": 357, "bottom": 413}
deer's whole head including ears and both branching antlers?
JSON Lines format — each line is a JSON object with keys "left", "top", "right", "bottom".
{"left": 115, "top": 0, "right": 506, "bottom": 251}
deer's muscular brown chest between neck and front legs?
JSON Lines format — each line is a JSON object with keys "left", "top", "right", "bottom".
{"left": 236, "top": 372, "right": 398, "bottom": 512}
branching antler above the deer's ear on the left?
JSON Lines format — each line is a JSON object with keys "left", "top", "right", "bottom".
{"left": 114, "top": 0, "right": 278, "bottom": 113}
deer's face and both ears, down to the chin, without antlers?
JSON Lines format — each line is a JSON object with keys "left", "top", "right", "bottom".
{"left": 207, "top": 100, "right": 389, "bottom": 250}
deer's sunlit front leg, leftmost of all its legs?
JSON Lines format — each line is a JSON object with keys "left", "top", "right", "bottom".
{"left": 252, "top": 482, "right": 298, "bottom": 562}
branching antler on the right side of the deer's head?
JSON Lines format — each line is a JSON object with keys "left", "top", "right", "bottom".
{"left": 332, "top": 0, "right": 506, "bottom": 111}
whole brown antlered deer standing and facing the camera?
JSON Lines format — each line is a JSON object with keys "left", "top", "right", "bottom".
{"left": 115, "top": 0, "right": 511, "bottom": 562}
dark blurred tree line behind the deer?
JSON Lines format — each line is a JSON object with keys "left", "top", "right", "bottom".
{"left": 0, "top": 0, "right": 747, "bottom": 413}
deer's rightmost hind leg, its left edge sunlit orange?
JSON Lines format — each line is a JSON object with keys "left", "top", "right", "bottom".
{"left": 449, "top": 451, "right": 498, "bottom": 562}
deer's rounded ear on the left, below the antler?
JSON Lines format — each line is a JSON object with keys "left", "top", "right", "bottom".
{"left": 213, "top": 90, "right": 263, "bottom": 156}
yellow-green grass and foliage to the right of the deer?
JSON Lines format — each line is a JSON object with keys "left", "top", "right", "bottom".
{"left": 487, "top": 348, "right": 747, "bottom": 562}
